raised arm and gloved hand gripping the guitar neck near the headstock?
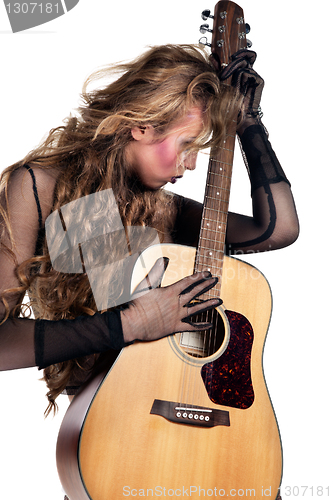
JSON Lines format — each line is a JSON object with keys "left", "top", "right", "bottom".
{"left": 175, "top": 50, "right": 299, "bottom": 253}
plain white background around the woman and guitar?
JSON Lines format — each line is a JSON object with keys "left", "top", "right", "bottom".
{"left": 0, "top": 0, "right": 333, "bottom": 500}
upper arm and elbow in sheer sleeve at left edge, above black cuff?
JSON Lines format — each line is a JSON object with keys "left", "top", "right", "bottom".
{"left": 0, "top": 167, "right": 54, "bottom": 370}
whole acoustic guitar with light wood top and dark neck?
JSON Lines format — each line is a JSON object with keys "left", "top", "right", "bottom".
{"left": 57, "top": 1, "right": 282, "bottom": 500}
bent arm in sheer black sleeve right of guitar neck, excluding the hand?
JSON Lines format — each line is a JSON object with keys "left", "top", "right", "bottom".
{"left": 227, "top": 114, "right": 299, "bottom": 253}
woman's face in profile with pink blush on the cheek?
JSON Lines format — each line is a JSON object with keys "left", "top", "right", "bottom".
{"left": 126, "top": 107, "right": 203, "bottom": 189}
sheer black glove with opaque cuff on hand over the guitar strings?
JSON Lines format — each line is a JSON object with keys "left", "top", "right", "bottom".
{"left": 33, "top": 258, "right": 222, "bottom": 368}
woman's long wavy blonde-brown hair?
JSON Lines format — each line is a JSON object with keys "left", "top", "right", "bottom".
{"left": 2, "top": 45, "right": 241, "bottom": 414}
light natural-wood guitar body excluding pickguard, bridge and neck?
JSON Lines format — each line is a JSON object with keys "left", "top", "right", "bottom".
{"left": 57, "top": 245, "right": 282, "bottom": 500}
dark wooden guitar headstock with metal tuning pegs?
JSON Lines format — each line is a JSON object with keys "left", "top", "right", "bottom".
{"left": 200, "top": 0, "right": 252, "bottom": 66}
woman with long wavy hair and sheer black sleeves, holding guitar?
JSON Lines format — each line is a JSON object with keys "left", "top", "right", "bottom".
{"left": 0, "top": 46, "right": 298, "bottom": 422}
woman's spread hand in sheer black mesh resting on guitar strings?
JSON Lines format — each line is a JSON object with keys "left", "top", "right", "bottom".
{"left": 121, "top": 259, "right": 222, "bottom": 342}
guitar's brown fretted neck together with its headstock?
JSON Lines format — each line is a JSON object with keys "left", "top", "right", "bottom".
{"left": 194, "top": 0, "right": 247, "bottom": 299}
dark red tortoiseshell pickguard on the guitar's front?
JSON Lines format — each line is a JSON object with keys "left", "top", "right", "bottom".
{"left": 201, "top": 311, "right": 254, "bottom": 409}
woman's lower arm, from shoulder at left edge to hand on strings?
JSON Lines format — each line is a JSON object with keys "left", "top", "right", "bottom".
{"left": 0, "top": 168, "right": 221, "bottom": 370}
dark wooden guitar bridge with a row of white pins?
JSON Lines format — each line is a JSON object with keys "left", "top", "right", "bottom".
{"left": 150, "top": 399, "right": 230, "bottom": 427}
